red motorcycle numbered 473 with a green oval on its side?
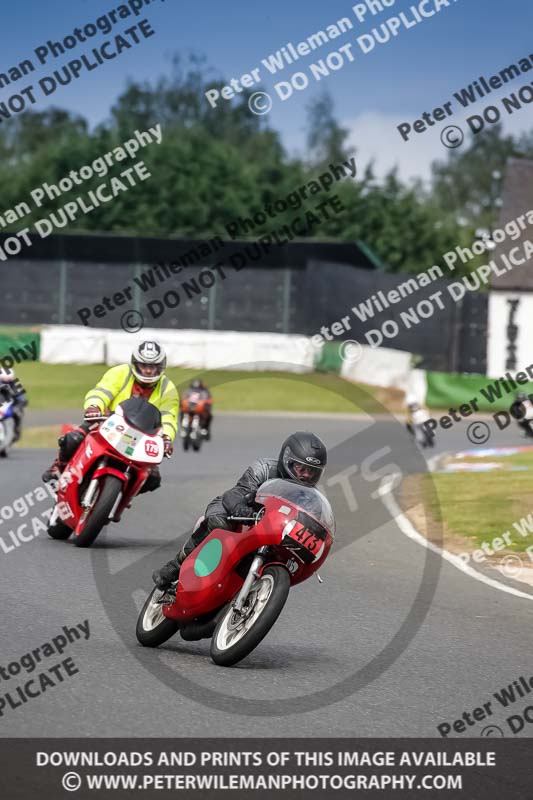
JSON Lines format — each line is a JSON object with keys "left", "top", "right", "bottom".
{"left": 136, "top": 479, "right": 335, "bottom": 667}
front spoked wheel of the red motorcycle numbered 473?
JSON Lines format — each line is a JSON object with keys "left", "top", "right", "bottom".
{"left": 211, "top": 566, "right": 291, "bottom": 667}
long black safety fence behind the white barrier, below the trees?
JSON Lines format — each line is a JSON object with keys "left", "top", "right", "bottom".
{"left": 0, "top": 228, "right": 488, "bottom": 373}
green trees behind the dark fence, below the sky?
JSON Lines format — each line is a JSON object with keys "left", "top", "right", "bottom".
{"left": 0, "top": 57, "right": 533, "bottom": 272}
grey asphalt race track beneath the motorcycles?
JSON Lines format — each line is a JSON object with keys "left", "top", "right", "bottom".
{"left": 0, "top": 415, "right": 533, "bottom": 737}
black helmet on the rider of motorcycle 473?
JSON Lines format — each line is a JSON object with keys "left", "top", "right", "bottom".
{"left": 278, "top": 431, "right": 328, "bottom": 486}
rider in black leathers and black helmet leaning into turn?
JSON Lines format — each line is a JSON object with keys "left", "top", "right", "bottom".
{"left": 152, "top": 431, "right": 328, "bottom": 589}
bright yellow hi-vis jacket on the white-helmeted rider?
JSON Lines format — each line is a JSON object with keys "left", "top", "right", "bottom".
{"left": 83, "top": 364, "right": 179, "bottom": 440}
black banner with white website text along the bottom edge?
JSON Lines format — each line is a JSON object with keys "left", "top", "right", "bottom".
{"left": 0, "top": 739, "right": 533, "bottom": 800}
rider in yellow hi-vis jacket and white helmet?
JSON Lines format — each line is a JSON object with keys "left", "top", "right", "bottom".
{"left": 43, "top": 341, "right": 179, "bottom": 492}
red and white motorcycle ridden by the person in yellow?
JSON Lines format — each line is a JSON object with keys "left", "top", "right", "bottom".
{"left": 48, "top": 397, "right": 165, "bottom": 547}
